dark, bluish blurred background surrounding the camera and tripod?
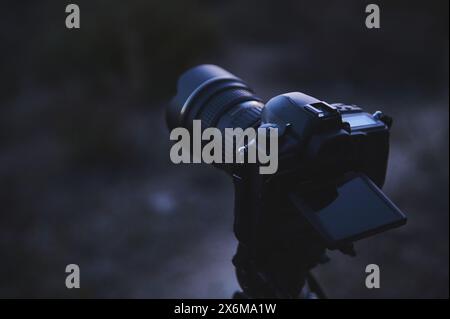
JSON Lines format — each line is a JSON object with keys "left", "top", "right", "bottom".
{"left": 0, "top": 0, "right": 449, "bottom": 298}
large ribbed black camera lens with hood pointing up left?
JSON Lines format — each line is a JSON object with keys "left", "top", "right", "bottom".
{"left": 166, "top": 64, "right": 264, "bottom": 130}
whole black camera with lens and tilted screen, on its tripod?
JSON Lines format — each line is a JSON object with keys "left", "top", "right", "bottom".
{"left": 167, "top": 65, "right": 406, "bottom": 298}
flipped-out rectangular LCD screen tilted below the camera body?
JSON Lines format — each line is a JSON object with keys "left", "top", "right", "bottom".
{"left": 291, "top": 176, "right": 406, "bottom": 243}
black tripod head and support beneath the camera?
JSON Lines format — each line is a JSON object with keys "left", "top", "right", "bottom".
{"left": 233, "top": 173, "right": 328, "bottom": 299}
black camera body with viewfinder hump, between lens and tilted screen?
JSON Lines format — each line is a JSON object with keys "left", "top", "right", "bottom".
{"left": 261, "top": 92, "right": 392, "bottom": 187}
